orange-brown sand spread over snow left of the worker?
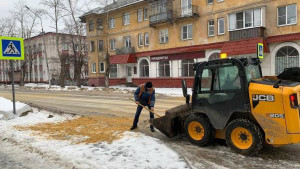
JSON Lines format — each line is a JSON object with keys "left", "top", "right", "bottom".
{"left": 16, "top": 116, "right": 132, "bottom": 143}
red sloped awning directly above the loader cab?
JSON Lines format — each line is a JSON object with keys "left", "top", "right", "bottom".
{"left": 222, "top": 38, "right": 270, "bottom": 55}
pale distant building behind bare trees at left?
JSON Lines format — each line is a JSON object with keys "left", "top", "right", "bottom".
{"left": 0, "top": 32, "right": 88, "bottom": 84}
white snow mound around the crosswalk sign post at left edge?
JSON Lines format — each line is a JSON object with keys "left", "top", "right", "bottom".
{"left": 0, "top": 97, "right": 31, "bottom": 120}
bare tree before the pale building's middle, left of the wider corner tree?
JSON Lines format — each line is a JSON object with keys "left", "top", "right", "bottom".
{"left": 41, "top": 0, "right": 67, "bottom": 87}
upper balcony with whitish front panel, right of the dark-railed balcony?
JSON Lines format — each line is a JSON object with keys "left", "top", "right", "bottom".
{"left": 174, "top": 5, "right": 199, "bottom": 20}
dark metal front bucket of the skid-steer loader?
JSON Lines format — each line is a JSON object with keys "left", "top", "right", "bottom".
{"left": 152, "top": 104, "right": 191, "bottom": 138}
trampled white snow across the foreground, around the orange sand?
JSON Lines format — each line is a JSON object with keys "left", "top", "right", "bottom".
{"left": 0, "top": 109, "right": 188, "bottom": 169}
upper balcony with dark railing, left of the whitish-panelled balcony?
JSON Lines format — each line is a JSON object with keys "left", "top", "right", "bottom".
{"left": 150, "top": 10, "right": 173, "bottom": 27}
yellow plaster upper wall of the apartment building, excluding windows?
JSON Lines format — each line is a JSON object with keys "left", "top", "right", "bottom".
{"left": 86, "top": 0, "right": 300, "bottom": 77}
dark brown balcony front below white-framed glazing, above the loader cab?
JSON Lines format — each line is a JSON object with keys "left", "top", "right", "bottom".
{"left": 229, "top": 27, "right": 265, "bottom": 41}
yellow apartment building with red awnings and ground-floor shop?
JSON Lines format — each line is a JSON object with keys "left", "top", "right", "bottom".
{"left": 81, "top": 0, "right": 300, "bottom": 87}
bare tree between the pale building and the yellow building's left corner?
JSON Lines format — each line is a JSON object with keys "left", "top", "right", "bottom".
{"left": 62, "top": 0, "right": 86, "bottom": 87}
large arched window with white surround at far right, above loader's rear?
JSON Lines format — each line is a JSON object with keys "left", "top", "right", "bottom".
{"left": 275, "top": 46, "right": 300, "bottom": 75}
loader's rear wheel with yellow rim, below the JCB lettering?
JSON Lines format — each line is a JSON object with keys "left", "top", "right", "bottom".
{"left": 225, "top": 119, "right": 264, "bottom": 156}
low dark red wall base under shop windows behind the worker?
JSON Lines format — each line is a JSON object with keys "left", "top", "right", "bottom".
{"left": 132, "top": 77, "right": 194, "bottom": 88}
